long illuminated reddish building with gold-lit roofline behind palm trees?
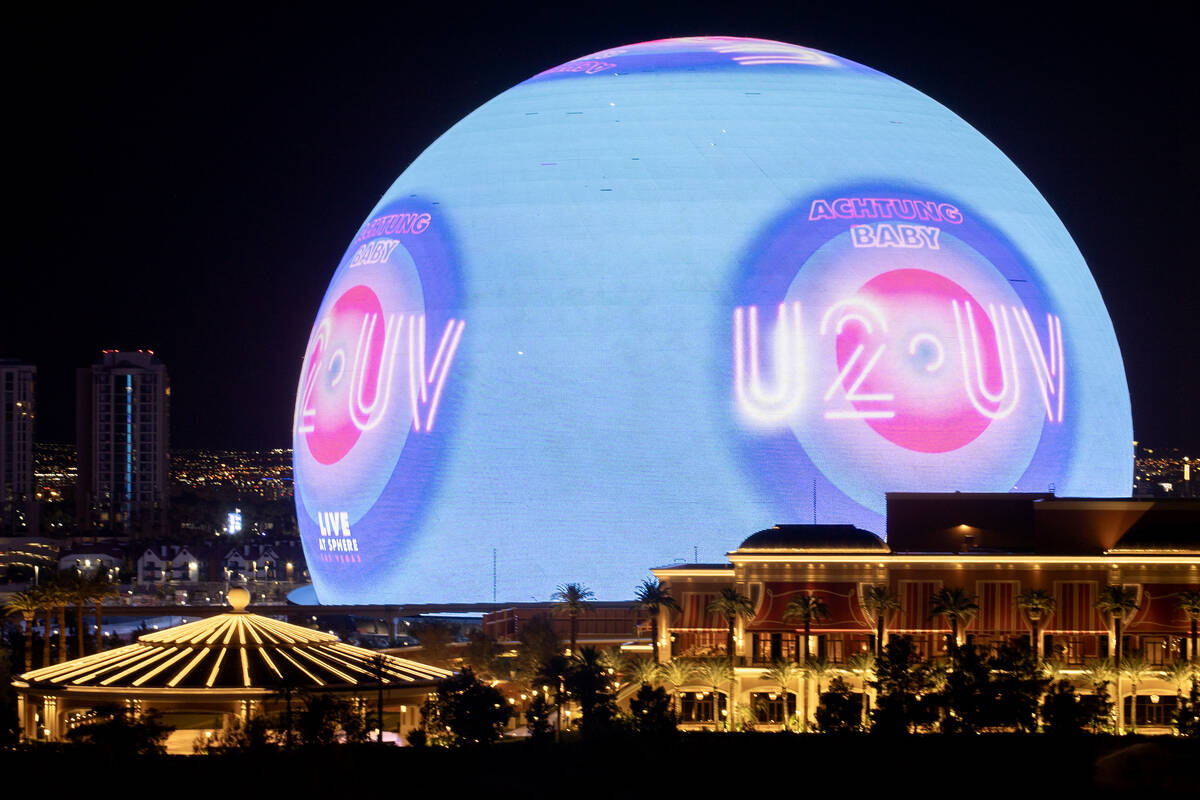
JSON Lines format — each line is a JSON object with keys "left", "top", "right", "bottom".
{"left": 654, "top": 494, "right": 1200, "bottom": 727}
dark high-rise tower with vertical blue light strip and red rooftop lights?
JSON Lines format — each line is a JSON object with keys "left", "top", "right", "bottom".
{"left": 76, "top": 350, "right": 170, "bottom": 535}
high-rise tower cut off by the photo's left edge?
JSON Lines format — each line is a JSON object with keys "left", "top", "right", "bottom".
{"left": 0, "top": 359, "right": 37, "bottom": 536}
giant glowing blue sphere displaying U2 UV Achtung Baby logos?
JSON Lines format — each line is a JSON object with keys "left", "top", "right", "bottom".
{"left": 293, "top": 38, "right": 1133, "bottom": 603}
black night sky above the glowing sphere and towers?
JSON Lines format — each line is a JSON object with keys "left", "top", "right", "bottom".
{"left": 0, "top": 1, "right": 1200, "bottom": 453}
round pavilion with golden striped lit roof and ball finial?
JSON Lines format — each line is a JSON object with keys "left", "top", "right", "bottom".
{"left": 13, "top": 589, "right": 451, "bottom": 752}
